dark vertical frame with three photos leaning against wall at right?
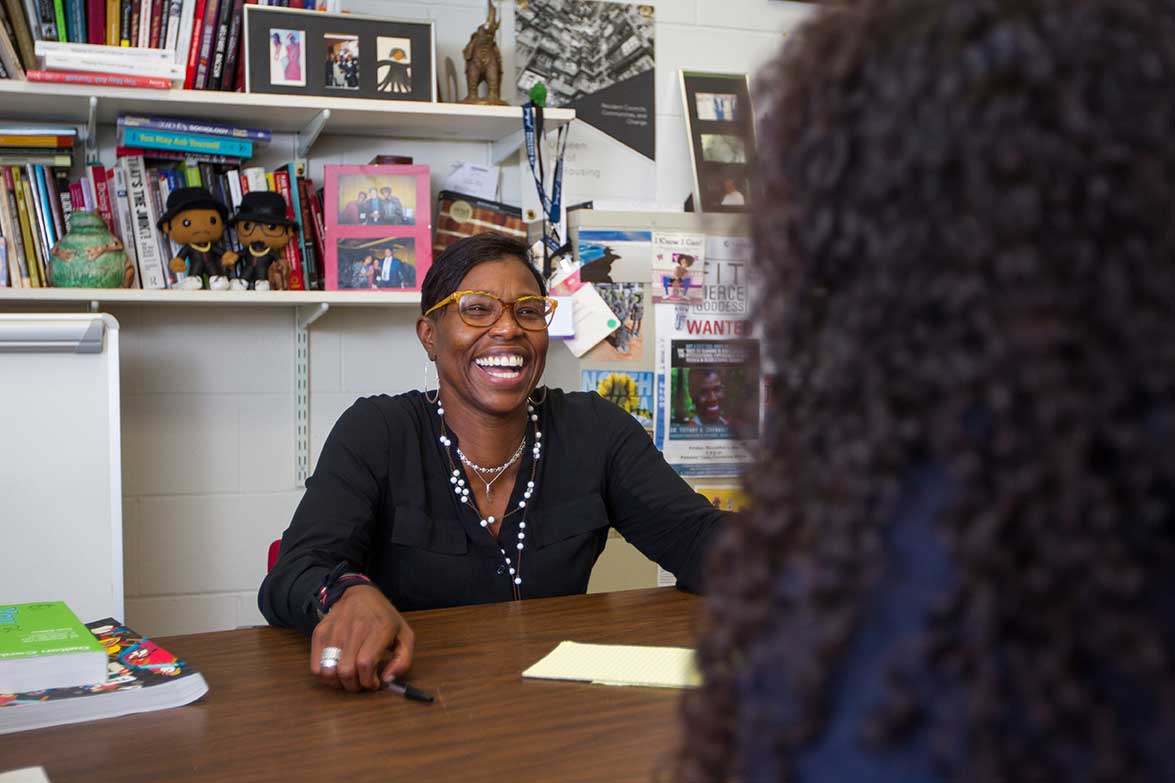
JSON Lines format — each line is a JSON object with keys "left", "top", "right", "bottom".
{"left": 680, "top": 71, "right": 754, "bottom": 212}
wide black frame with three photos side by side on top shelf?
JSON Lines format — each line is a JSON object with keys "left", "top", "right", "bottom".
{"left": 244, "top": 5, "right": 436, "bottom": 101}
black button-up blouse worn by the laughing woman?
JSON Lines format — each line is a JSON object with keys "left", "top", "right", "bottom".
{"left": 259, "top": 389, "right": 727, "bottom": 633}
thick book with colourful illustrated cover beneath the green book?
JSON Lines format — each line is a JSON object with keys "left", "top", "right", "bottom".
{"left": 0, "top": 617, "right": 208, "bottom": 734}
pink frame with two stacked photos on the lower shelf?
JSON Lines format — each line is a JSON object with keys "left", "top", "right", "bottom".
{"left": 322, "top": 166, "right": 432, "bottom": 290}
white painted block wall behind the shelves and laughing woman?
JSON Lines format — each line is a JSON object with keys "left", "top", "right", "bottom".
{"left": 4, "top": 0, "right": 811, "bottom": 636}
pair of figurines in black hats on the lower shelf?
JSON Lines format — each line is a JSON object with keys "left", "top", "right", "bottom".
{"left": 157, "top": 188, "right": 297, "bottom": 290}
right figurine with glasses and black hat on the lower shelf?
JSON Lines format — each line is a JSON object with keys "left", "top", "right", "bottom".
{"left": 231, "top": 190, "right": 297, "bottom": 290}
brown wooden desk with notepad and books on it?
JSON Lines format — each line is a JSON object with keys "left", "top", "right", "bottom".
{"left": 0, "top": 588, "right": 700, "bottom": 783}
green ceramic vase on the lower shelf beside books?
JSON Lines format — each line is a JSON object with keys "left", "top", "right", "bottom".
{"left": 49, "top": 212, "right": 130, "bottom": 288}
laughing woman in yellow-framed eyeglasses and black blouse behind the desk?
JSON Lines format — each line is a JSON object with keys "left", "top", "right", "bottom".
{"left": 259, "top": 234, "right": 725, "bottom": 691}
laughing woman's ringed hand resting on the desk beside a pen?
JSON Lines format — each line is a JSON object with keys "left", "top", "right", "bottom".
{"left": 310, "top": 584, "right": 416, "bottom": 692}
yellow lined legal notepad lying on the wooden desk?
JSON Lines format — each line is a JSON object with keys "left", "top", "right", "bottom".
{"left": 522, "top": 642, "right": 701, "bottom": 688}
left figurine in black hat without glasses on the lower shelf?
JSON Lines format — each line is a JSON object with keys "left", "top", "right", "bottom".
{"left": 157, "top": 188, "right": 242, "bottom": 290}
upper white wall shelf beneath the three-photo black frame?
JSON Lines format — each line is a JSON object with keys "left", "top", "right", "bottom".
{"left": 0, "top": 79, "right": 576, "bottom": 141}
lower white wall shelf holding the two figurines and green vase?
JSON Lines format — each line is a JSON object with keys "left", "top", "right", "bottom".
{"left": 0, "top": 288, "right": 421, "bottom": 307}
